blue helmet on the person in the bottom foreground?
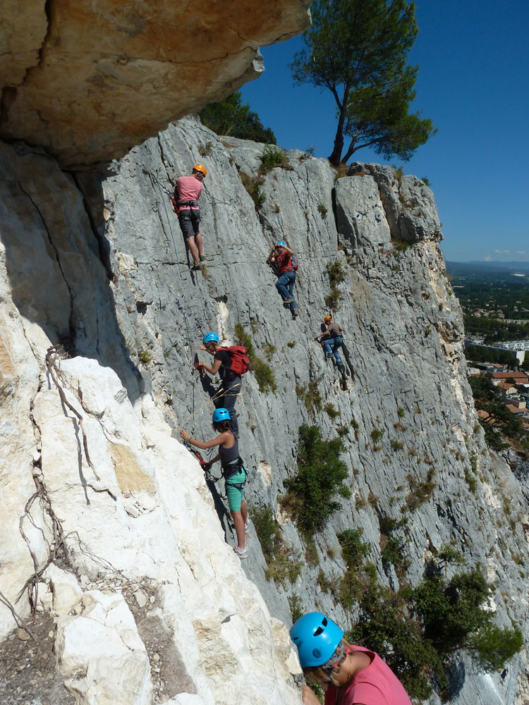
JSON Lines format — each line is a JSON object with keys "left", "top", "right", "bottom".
{"left": 290, "top": 612, "right": 344, "bottom": 668}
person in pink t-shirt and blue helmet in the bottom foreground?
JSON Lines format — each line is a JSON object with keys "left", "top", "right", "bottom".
{"left": 290, "top": 612, "right": 411, "bottom": 705}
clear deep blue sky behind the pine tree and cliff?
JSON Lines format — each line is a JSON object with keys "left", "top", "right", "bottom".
{"left": 242, "top": 0, "right": 529, "bottom": 262}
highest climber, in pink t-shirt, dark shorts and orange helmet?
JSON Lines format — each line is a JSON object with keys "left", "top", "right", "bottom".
{"left": 175, "top": 164, "right": 207, "bottom": 269}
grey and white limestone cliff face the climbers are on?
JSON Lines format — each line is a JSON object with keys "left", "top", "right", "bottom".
{"left": 0, "top": 119, "right": 529, "bottom": 705}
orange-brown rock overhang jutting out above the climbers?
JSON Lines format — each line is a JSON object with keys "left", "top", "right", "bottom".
{"left": 0, "top": 0, "right": 309, "bottom": 165}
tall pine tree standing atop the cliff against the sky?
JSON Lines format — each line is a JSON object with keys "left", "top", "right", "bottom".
{"left": 290, "top": 0, "right": 437, "bottom": 165}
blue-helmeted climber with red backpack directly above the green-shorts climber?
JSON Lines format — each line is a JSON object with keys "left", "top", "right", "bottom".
{"left": 195, "top": 333, "right": 250, "bottom": 438}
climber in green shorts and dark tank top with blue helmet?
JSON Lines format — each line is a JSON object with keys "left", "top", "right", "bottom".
{"left": 180, "top": 409, "right": 250, "bottom": 560}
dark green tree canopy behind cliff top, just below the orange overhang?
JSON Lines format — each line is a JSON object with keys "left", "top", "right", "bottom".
{"left": 199, "top": 91, "right": 276, "bottom": 144}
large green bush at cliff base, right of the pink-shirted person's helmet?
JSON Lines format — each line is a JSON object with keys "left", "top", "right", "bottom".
{"left": 337, "top": 541, "right": 523, "bottom": 701}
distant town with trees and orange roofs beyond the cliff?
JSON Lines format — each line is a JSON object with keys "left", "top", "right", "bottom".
{"left": 447, "top": 263, "right": 529, "bottom": 455}
